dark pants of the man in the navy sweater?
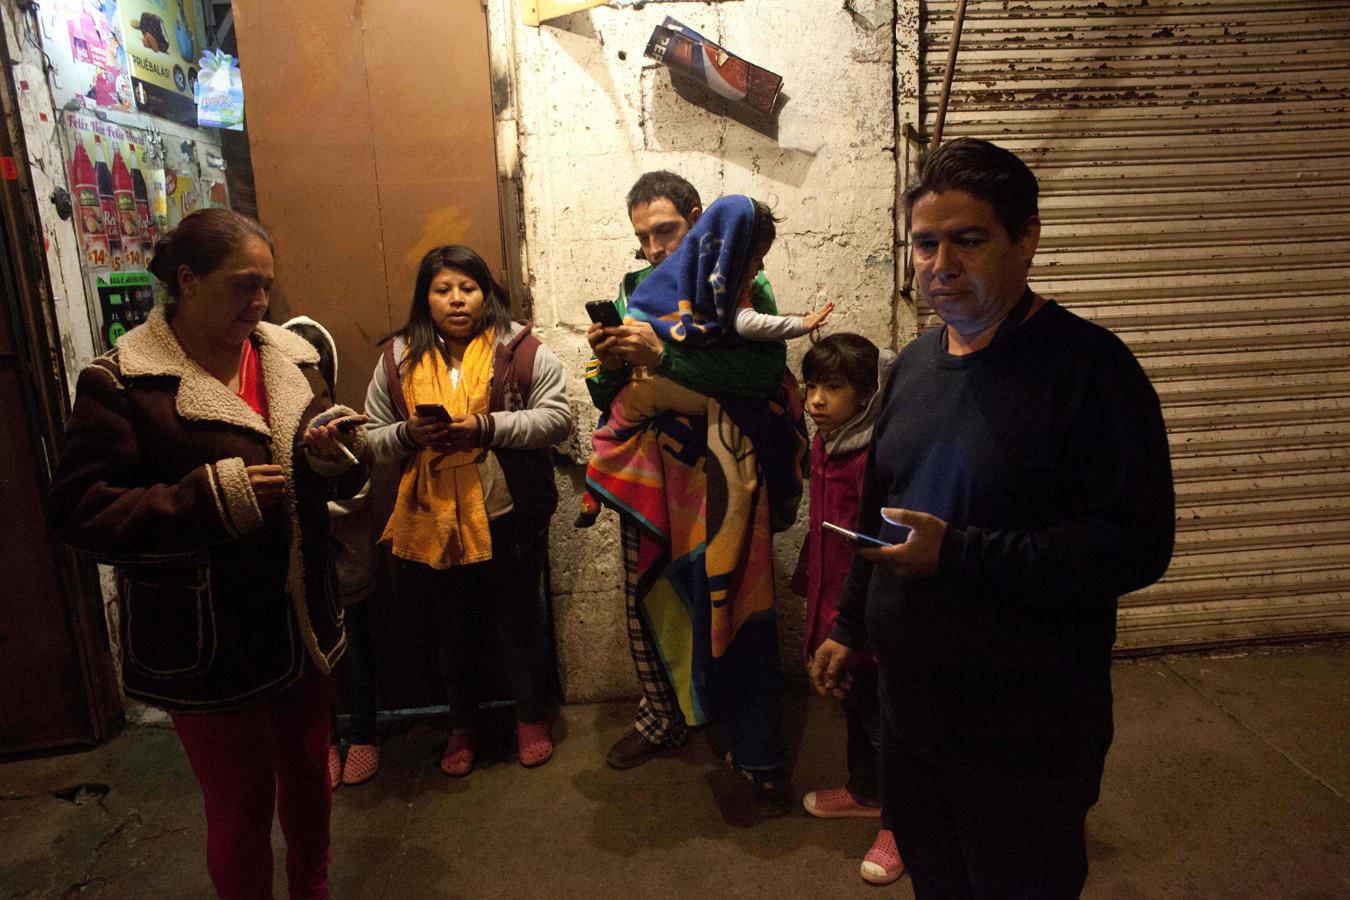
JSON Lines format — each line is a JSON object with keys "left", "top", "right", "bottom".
{"left": 882, "top": 727, "right": 1102, "bottom": 900}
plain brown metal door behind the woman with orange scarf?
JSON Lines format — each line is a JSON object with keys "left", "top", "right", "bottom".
{"left": 234, "top": 0, "right": 504, "bottom": 407}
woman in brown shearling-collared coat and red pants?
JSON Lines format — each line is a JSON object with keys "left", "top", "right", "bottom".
{"left": 50, "top": 209, "right": 365, "bottom": 897}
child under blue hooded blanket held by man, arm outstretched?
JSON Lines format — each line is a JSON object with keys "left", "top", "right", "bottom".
{"left": 575, "top": 194, "right": 834, "bottom": 528}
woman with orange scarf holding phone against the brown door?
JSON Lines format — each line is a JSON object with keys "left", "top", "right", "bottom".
{"left": 366, "top": 244, "right": 572, "bottom": 776}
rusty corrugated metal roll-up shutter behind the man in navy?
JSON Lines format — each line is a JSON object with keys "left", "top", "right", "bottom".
{"left": 919, "top": 0, "right": 1350, "bottom": 648}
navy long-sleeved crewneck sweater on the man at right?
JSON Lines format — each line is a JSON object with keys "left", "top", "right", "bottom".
{"left": 832, "top": 301, "right": 1175, "bottom": 777}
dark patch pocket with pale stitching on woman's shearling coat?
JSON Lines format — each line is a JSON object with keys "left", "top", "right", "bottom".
{"left": 117, "top": 565, "right": 216, "bottom": 677}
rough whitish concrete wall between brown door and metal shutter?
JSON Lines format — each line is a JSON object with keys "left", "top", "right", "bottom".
{"left": 490, "top": 0, "right": 896, "bottom": 700}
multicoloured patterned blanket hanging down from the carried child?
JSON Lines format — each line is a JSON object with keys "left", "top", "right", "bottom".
{"left": 586, "top": 378, "right": 806, "bottom": 739}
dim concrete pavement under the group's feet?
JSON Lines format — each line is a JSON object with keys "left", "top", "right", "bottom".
{"left": 0, "top": 641, "right": 1350, "bottom": 900}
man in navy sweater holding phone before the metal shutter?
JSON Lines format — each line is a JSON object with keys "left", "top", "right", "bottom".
{"left": 811, "top": 139, "right": 1175, "bottom": 900}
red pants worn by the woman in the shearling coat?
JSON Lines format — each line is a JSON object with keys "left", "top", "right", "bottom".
{"left": 173, "top": 669, "right": 333, "bottom": 900}
